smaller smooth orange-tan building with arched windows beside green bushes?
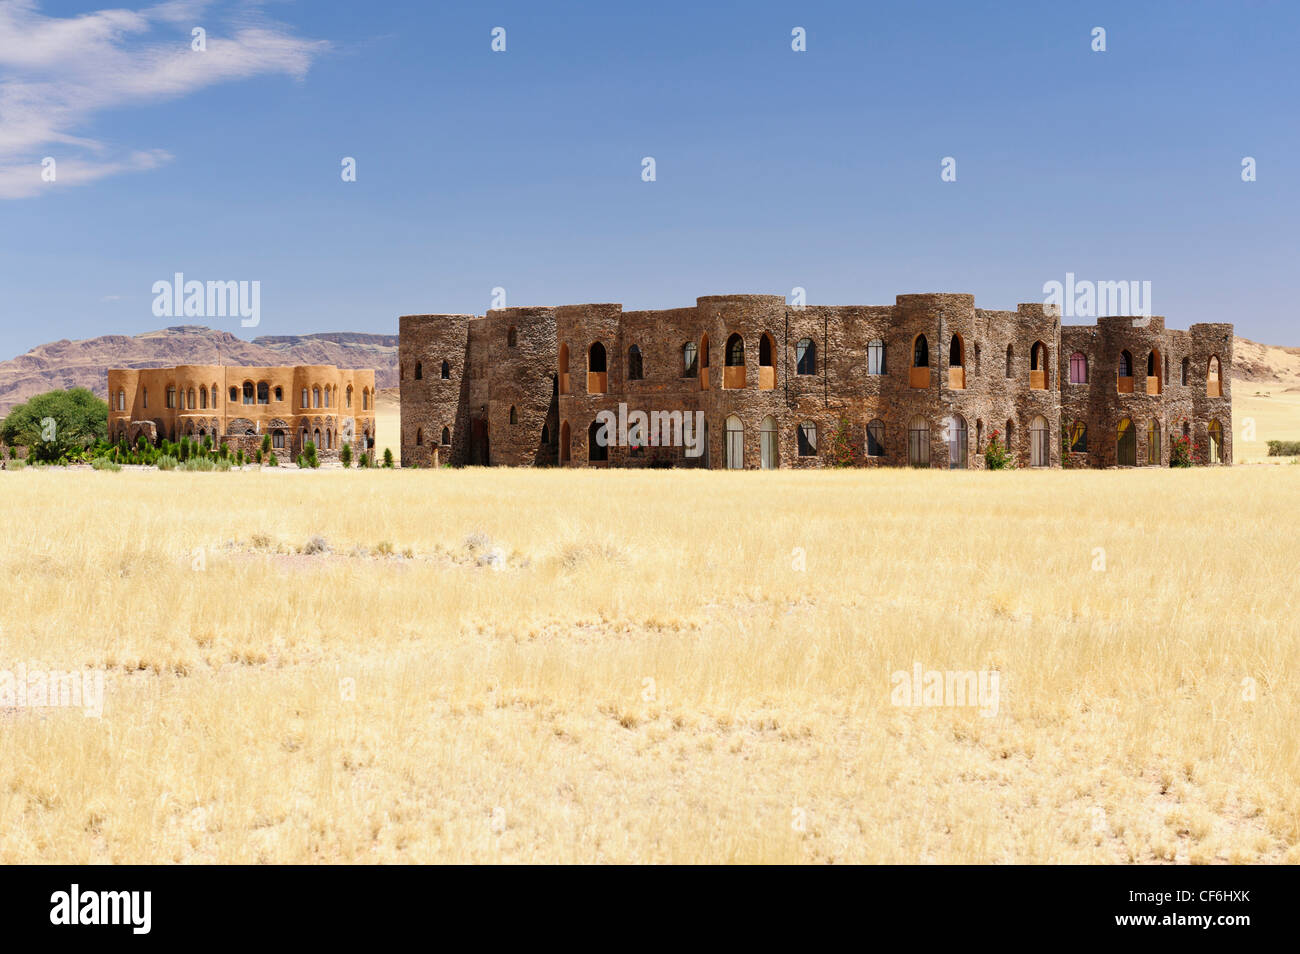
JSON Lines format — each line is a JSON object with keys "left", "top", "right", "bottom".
{"left": 108, "top": 364, "right": 374, "bottom": 459}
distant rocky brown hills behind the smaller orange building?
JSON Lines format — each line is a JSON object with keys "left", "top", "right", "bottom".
{"left": 0, "top": 325, "right": 398, "bottom": 415}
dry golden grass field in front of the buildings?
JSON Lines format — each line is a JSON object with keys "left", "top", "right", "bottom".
{"left": 0, "top": 467, "right": 1300, "bottom": 863}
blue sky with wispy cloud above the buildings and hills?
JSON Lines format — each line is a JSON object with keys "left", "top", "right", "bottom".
{"left": 0, "top": 0, "right": 1300, "bottom": 356}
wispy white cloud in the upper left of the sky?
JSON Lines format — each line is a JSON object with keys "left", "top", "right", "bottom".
{"left": 0, "top": 0, "right": 329, "bottom": 199}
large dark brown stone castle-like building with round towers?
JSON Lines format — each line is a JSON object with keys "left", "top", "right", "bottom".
{"left": 399, "top": 294, "right": 1232, "bottom": 468}
